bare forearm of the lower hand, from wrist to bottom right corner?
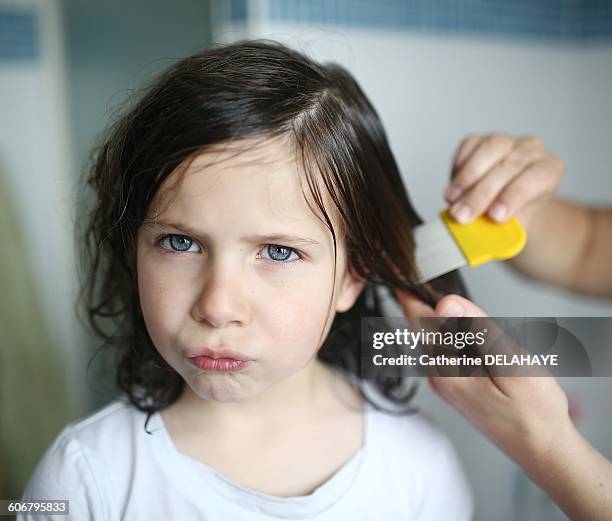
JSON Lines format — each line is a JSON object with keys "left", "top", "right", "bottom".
{"left": 530, "top": 422, "right": 612, "bottom": 521}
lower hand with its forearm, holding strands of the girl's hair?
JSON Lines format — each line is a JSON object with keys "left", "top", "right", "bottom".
{"left": 396, "top": 290, "right": 612, "bottom": 521}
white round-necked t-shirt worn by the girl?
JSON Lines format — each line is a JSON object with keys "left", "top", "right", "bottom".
{"left": 17, "top": 394, "right": 473, "bottom": 521}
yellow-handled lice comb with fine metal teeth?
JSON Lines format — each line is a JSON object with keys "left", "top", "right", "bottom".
{"left": 414, "top": 210, "right": 527, "bottom": 282}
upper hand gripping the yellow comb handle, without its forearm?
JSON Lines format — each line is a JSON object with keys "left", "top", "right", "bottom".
{"left": 445, "top": 133, "right": 565, "bottom": 224}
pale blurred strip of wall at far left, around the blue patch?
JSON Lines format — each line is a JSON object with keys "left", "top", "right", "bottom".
{"left": 0, "top": 0, "right": 82, "bottom": 404}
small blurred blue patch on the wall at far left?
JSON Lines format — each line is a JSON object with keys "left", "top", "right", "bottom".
{"left": 0, "top": 8, "right": 39, "bottom": 62}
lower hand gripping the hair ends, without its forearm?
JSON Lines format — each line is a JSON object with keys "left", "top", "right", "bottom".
{"left": 396, "top": 290, "right": 575, "bottom": 481}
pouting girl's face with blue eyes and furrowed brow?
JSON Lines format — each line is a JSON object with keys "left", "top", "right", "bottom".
{"left": 137, "top": 140, "right": 364, "bottom": 401}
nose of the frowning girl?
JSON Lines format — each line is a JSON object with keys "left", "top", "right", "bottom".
{"left": 192, "top": 259, "right": 250, "bottom": 328}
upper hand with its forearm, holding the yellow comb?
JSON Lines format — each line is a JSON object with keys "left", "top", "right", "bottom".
{"left": 445, "top": 133, "right": 612, "bottom": 297}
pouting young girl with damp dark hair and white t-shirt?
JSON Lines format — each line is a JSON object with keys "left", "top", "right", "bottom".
{"left": 19, "top": 42, "right": 473, "bottom": 520}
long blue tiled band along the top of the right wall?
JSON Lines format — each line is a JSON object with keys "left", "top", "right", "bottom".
{"left": 269, "top": 0, "right": 612, "bottom": 41}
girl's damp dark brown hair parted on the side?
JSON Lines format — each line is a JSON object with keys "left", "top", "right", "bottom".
{"left": 76, "top": 41, "right": 466, "bottom": 422}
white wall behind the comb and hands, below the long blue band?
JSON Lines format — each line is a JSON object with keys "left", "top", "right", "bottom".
{"left": 214, "top": 11, "right": 612, "bottom": 520}
